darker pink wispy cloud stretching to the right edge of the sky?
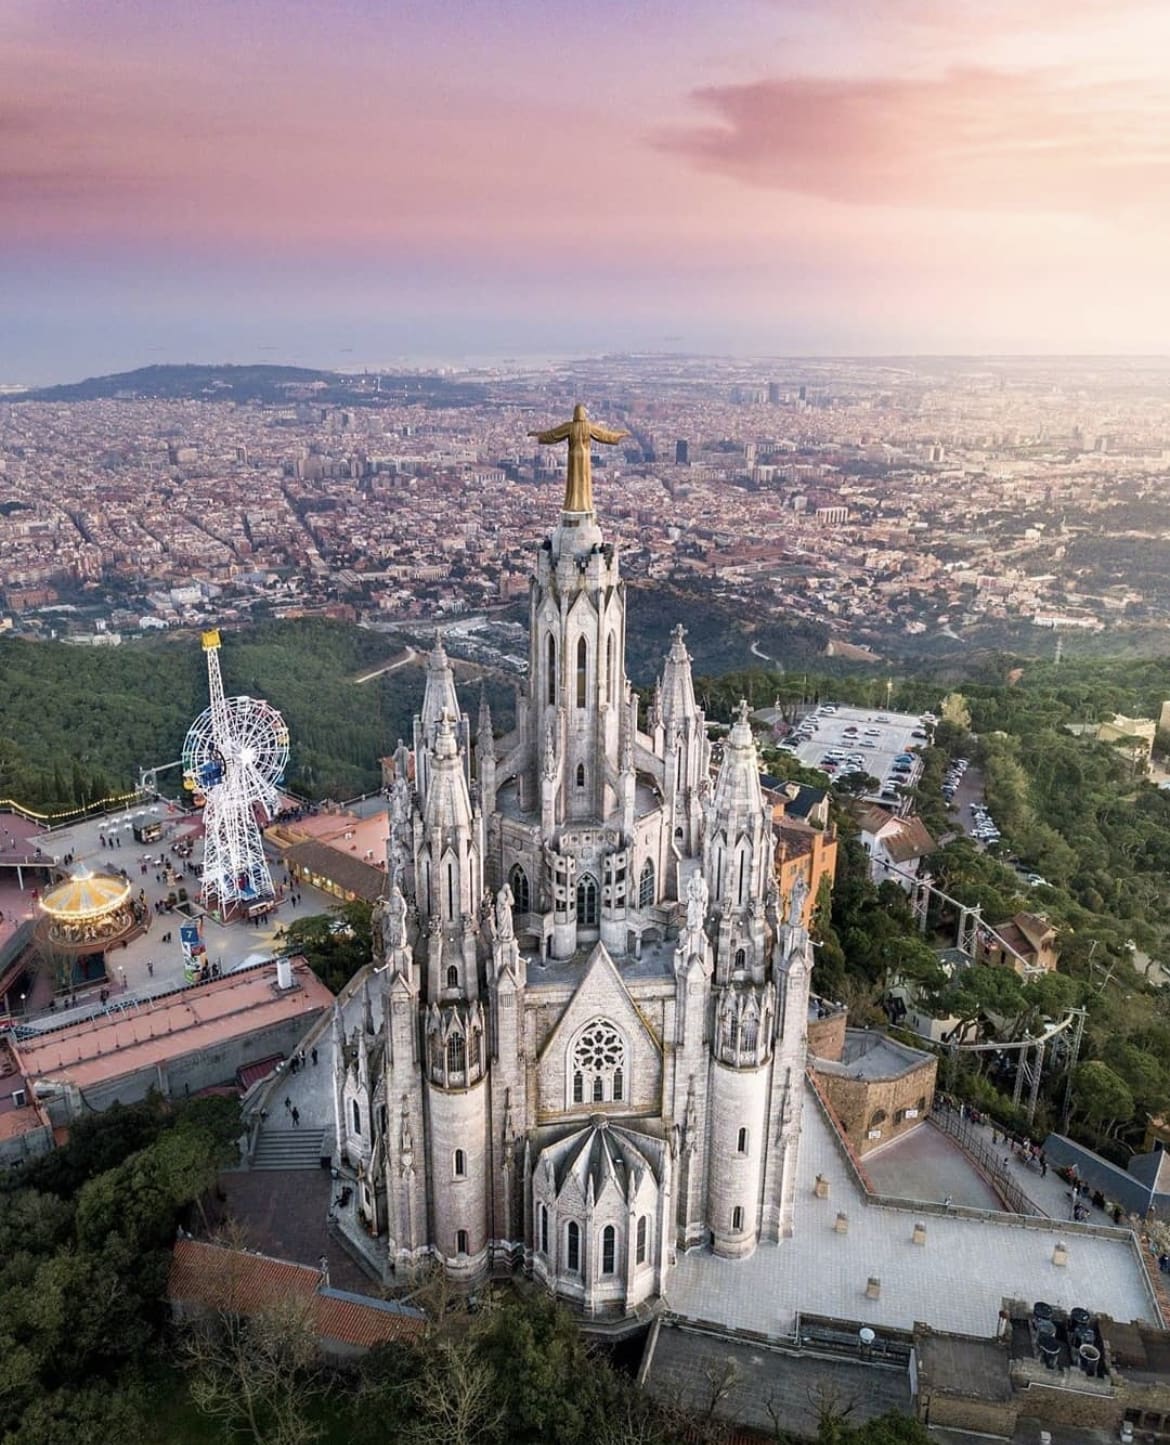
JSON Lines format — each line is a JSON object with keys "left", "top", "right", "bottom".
{"left": 660, "top": 68, "right": 1170, "bottom": 217}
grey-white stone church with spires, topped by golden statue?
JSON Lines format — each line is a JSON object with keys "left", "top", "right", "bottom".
{"left": 334, "top": 406, "right": 812, "bottom": 1318}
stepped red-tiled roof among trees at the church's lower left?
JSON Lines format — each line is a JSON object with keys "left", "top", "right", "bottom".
{"left": 166, "top": 1240, "right": 426, "bottom": 1350}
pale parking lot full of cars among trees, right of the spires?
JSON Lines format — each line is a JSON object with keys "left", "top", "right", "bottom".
{"left": 781, "top": 702, "right": 933, "bottom": 805}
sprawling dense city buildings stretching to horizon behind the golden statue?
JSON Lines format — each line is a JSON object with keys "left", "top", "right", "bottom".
{"left": 0, "top": 357, "right": 1170, "bottom": 666}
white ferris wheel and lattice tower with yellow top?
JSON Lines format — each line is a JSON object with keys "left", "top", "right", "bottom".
{"left": 182, "top": 631, "right": 289, "bottom": 910}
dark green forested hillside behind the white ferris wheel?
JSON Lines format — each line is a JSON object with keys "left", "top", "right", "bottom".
{"left": 0, "top": 618, "right": 513, "bottom": 811}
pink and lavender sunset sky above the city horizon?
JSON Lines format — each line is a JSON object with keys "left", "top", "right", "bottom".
{"left": 0, "top": 0, "right": 1170, "bottom": 383}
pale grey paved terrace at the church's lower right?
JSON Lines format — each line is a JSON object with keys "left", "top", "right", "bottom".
{"left": 666, "top": 1095, "right": 1157, "bottom": 1338}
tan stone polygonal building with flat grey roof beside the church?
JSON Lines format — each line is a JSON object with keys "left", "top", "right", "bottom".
{"left": 809, "top": 1029, "right": 937, "bottom": 1156}
